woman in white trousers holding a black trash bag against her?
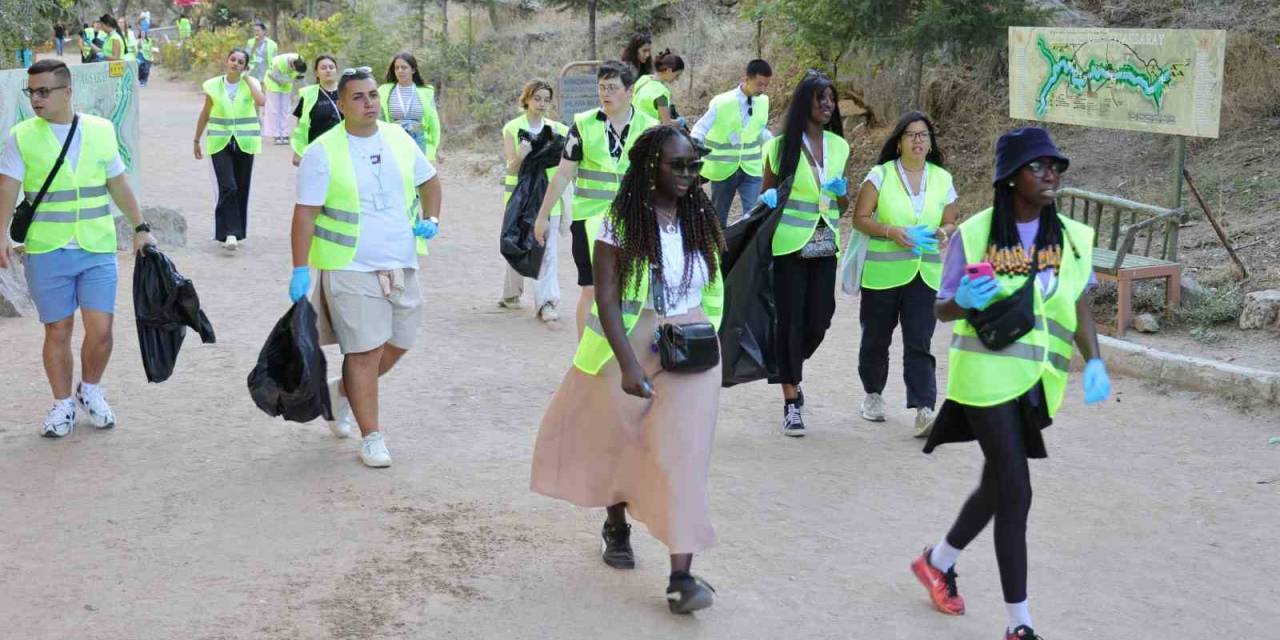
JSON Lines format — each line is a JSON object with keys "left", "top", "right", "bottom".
{"left": 498, "top": 79, "right": 572, "bottom": 323}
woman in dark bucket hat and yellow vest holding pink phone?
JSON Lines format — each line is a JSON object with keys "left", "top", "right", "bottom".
{"left": 911, "top": 127, "right": 1111, "bottom": 640}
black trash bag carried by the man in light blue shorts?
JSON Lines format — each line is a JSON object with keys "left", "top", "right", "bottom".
{"left": 133, "top": 246, "right": 218, "bottom": 383}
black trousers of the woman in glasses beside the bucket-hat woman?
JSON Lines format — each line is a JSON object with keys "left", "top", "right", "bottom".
{"left": 858, "top": 274, "right": 938, "bottom": 408}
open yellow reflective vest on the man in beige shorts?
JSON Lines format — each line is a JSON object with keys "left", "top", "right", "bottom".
{"left": 308, "top": 122, "right": 426, "bottom": 271}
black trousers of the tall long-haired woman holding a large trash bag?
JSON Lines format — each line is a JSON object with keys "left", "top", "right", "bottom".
{"left": 769, "top": 252, "right": 836, "bottom": 384}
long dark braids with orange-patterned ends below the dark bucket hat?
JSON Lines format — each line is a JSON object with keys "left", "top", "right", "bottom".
{"left": 984, "top": 183, "right": 1075, "bottom": 275}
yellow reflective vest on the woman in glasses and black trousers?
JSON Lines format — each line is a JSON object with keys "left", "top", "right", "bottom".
{"left": 861, "top": 160, "right": 951, "bottom": 291}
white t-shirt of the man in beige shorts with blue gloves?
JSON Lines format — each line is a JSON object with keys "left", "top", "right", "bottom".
{"left": 297, "top": 132, "right": 435, "bottom": 271}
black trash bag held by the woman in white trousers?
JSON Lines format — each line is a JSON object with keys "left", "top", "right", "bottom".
{"left": 498, "top": 127, "right": 564, "bottom": 278}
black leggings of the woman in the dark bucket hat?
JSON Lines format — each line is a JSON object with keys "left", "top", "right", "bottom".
{"left": 947, "top": 401, "right": 1032, "bottom": 603}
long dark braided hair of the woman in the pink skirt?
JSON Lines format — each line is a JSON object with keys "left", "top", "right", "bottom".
{"left": 609, "top": 125, "right": 724, "bottom": 302}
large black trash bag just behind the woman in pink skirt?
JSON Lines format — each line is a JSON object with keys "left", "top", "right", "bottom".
{"left": 719, "top": 178, "right": 791, "bottom": 387}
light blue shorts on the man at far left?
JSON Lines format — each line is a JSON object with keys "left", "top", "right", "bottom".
{"left": 26, "top": 248, "right": 119, "bottom": 324}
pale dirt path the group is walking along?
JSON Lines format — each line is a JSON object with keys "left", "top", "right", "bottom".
{"left": 0, "top": 72, "right": 1280, "bottom": 640}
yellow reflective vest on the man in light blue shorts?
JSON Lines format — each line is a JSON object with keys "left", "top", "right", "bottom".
{"left": 12, "top": 114, "right": 119, "bottom": 255}
